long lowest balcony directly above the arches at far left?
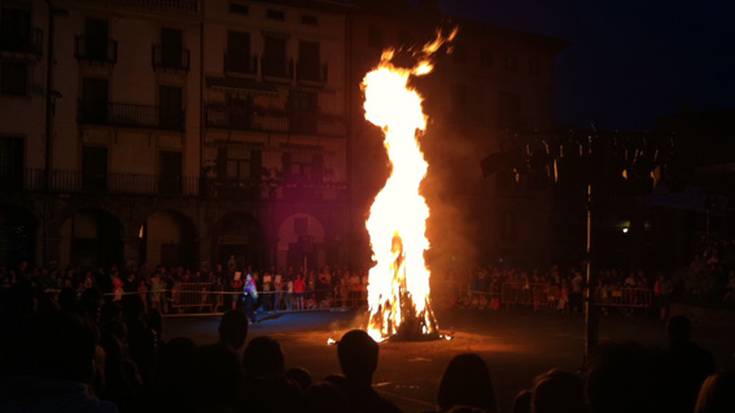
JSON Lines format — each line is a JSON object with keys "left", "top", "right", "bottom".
{"left": 0, "top": 168, "right": 199, "bottom": 196}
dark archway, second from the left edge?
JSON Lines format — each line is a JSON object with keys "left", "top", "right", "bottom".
{"left": 61, "top": 209, "right": 123, "bottom": 268}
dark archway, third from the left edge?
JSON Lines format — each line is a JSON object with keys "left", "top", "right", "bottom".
{"left": 138, "top": 211, "right": 199, "bottom": 268}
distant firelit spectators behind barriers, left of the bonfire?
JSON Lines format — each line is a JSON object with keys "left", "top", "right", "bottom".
{"left": 0, "top": 258, "right": 368, "bottom": 314}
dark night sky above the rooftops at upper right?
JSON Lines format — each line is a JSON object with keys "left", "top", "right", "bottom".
{"left": 441, "top": 0, "right": 735, "bottom": 129}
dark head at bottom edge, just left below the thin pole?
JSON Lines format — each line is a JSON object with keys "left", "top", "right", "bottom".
{"left": 531, "top": 370, "right": 586, "bottom": 413}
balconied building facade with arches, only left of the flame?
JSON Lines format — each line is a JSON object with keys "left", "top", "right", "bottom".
{"left": 0, "top": 0, "right": 347, "bottom": 268}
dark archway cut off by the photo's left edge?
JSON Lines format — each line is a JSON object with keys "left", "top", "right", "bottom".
{"left": 0, "top": 205, "right": 37, "bottom": 266}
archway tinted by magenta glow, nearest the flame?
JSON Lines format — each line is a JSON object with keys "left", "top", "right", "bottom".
{"left": 277, "top": 214, "right": 326, "bottom": 270}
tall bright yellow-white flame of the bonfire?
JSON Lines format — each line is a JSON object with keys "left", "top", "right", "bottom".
{"left": 362, "top": 29, "right": 457, "bottom": 342}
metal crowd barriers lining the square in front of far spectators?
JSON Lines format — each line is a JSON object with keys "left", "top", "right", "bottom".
{"left": 4, "top": 282, "right": 654, "bottom": 315}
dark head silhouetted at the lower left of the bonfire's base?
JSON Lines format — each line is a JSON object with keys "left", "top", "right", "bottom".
{"left": 337, "top": 330, "right": 379, "bottom": 385}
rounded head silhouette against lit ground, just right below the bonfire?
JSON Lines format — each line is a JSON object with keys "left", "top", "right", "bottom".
{"left": 437, "top": 353, "right": 497, "bottom": 412}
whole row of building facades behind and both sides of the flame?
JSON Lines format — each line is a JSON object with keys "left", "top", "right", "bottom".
{"left": 0, "top": 0, "right": 560, "bottom": 268}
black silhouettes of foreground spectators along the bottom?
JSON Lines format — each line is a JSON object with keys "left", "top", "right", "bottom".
{"left": 0, "top": 266, "right": 735, "bottom": 413}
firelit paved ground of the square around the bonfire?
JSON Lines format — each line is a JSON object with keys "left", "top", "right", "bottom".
{"left": 165, "top": 311, "right": 735, "bottom": 412}
